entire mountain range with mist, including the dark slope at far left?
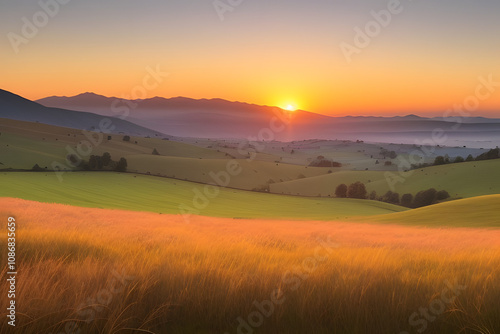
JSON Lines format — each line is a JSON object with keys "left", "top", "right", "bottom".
{"left": 0, "top": 90, "right": 500, "bottom": 147}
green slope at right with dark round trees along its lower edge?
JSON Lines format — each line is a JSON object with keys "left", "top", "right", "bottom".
{"left": 271, "top": 160, "right": 500, "bottom": 198}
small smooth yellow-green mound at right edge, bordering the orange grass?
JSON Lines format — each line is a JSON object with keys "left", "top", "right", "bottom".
{"left": 369, "top": 195, "right": 500, "bottom": 227}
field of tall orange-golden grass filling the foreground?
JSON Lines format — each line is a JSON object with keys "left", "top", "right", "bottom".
{"left": 0, "top": 198, "right": 500, "bottom": 334}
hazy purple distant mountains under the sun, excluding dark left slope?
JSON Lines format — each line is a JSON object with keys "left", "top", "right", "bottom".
{"left": 32, "top": 93, "right": 500, "bottom": 147}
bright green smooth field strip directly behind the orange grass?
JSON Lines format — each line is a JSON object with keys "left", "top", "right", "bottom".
{"left": 0, "top": 172, "right": 405, "bottom": 220}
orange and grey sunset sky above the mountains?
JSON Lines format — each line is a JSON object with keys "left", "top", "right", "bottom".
{"left": 0, "top": 0, "right": 500, "bottom": 118}
